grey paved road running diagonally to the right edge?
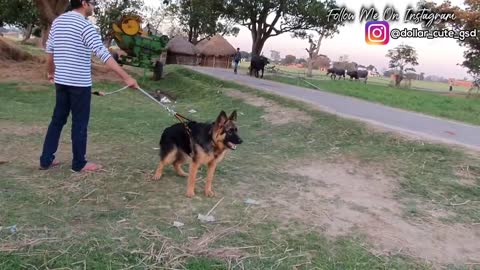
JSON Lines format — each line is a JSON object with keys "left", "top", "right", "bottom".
{"left": 190, "top": 66, "right": 480, "bottom": 151}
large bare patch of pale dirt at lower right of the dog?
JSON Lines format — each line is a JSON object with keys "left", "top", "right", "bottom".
{"left": 266, "top": 160, "right": 480, "bottom": 268}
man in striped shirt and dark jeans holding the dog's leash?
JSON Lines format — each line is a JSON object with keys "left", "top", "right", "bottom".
{"left": 40, "top": 0, "right": 138, "bottom": 172}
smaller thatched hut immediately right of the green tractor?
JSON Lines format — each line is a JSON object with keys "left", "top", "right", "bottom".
{"left": 166, "top": 36, "right": 197, "bottom": 65}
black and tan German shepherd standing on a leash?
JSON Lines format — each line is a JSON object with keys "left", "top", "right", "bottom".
{"left": 153, "top": 111, "right": 242, "bottom": 198}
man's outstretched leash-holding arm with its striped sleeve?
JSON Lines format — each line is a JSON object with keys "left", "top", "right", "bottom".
{"left": 82, "top": 24, "right": 138, "bottom": 88}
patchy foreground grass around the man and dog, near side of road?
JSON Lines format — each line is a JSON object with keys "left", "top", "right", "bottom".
{"left": 0, "top": 66, "right": 480, "bottom": 269}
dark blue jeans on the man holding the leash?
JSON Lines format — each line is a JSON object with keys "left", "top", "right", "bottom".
{"left": 40, "top": 84, "right": 92, "bottom": 171}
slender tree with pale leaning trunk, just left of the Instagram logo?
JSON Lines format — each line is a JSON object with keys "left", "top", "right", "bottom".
{"left": 295, "top": 0, "right": 343, "bottom": 77}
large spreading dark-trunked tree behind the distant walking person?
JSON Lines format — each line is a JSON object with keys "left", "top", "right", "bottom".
{"left": 226, "top": 0, "right": 334, "bottom": 55}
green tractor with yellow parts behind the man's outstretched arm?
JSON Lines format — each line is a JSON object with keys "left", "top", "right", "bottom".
{"left": 112, "top": 15, "right": 168, "bottom": 80}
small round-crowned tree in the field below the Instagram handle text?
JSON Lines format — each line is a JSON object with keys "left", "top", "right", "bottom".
{"left": 386, "top": 44, "right": 418, "bottom": 87}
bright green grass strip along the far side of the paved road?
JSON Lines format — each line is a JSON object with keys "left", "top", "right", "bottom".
{"left": 265, "top": 75, "right": 480, "bottom": 125}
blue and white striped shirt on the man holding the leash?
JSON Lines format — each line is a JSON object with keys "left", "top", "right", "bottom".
{"left": 45, "top": 11, "right": 111, "bottom": 87}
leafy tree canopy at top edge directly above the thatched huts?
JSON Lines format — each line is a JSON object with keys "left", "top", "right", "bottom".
{"left": 169, "top": 0, "right": 240, "bottom": 44}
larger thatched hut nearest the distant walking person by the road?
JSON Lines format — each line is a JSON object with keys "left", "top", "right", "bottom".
{"left": 197, "top": 35, "right": 236, "bottom": 68}
